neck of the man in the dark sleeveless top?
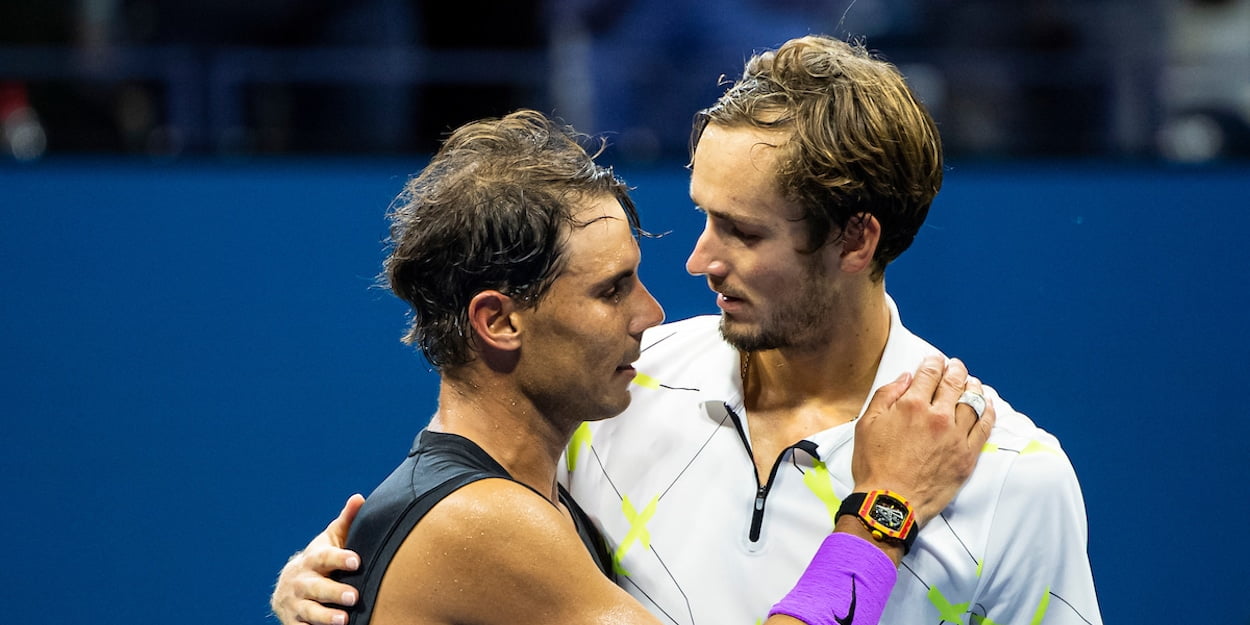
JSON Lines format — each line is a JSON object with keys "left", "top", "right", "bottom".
{"left": 429, "top": 376, "right": 578, "bottom": 503}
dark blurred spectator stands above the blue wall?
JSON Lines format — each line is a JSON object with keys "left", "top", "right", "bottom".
{"left": 0, "top": 0, "right": 1250, "bottom": 161}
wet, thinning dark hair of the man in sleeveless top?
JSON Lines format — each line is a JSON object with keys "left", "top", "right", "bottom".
{"left": 383, "top": 110, "right": 641, "bottom": 370}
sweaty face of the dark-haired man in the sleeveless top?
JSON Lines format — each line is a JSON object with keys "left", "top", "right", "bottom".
{"left": 519, "top": 196, "right": 664, "bottom": 420}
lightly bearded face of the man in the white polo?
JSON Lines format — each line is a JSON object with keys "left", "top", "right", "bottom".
{"left": 686, "top": 124, "right": 840, "bottom": 351}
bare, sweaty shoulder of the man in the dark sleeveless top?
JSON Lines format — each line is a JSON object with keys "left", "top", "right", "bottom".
{"left": 373, "top": 479, "right": 645, "bottom": 625}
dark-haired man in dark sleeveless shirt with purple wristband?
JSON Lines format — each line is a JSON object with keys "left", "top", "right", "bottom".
{"left": 275, "top": 111, "right": 994, "bottom": 625}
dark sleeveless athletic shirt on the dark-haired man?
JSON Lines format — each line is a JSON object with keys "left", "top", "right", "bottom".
{"left": 334, "top": 430, "right": 611, "bottom": 625}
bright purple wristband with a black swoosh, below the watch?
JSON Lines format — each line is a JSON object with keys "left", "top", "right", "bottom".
{"left": 769, "top": 534, "right": 899, "bottom": 625}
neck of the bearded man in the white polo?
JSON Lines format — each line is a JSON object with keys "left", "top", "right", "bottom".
{"left": 743, "top": 286, "right": 890, "bottom": 414}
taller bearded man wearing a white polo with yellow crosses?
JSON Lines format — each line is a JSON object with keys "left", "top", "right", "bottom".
{"left": 552, "top": 38, "right": 1101, "bottom": 625}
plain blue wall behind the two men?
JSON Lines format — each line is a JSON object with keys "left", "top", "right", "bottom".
{"left": 0, "top": 161, "right": 1250, "bottom": 625}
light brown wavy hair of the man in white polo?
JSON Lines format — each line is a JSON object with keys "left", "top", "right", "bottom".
{"left": 690, "top": 36, "right": 943, "bottom": 279}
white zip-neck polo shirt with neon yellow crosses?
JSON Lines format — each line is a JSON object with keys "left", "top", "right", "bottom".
{"left": 561, "top": 298, "right": 1101, "bottom": 625}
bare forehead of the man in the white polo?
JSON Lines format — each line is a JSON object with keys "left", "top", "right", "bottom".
{"left": 690, "top": 124, "right": 799, "bottom": 219}
